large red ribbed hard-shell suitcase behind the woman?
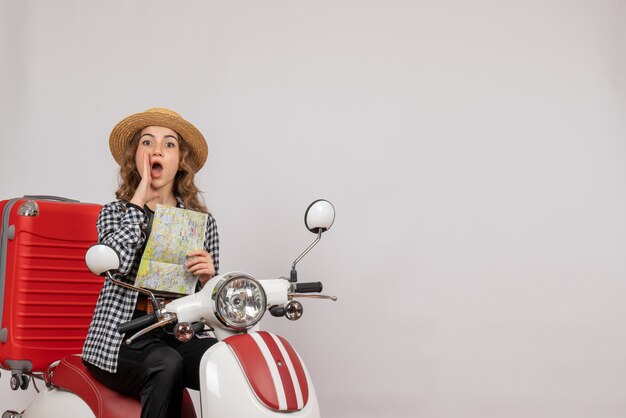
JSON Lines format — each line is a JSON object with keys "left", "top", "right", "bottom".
{"left": 0, "top": 196, "right": 102, "bottom": 385}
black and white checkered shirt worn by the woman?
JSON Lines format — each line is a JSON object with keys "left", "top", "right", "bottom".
{"left": 82, "top": 201, "right": 219, "bottom": 373}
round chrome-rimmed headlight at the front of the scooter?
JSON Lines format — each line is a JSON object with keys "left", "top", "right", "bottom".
{"left": 212, "top": 274, "right": 267, "bottom": 331}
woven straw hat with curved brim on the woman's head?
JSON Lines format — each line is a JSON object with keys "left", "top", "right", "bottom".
{"left": 109, "top": 110, "right": 209, "bottom": 173}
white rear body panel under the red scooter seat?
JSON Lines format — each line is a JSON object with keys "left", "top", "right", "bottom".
{"left": 22, "top": 388, "right": 95, "bottom": 418}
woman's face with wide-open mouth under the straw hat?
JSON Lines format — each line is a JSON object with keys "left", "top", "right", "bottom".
{"left": 135, "top": 126, "right": 180, "bottom": 189}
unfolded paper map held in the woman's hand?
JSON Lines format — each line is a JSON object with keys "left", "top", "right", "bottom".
{"left": 135, "top": 205, "right": 208, "bottom": 294}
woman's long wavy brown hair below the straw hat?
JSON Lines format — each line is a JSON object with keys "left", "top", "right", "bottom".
{"left": 115, "top": 131, "right": 208, "bottom": 213}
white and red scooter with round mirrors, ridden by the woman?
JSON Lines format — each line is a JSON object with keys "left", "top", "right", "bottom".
{"left": 2, "top": 200, "right": 337, "bottom": 418}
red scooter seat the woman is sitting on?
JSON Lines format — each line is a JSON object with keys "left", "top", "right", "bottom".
{"left": 51, "top": 355, "right": 196, "bottom": 418}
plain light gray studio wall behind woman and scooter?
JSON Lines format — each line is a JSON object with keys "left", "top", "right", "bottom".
{"left": 0, "top": 0, "right": 626, "bottom": 418}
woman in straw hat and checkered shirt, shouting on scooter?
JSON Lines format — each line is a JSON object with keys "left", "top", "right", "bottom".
{"left": 82, "top": 108, "right": 219, "bottom": 418}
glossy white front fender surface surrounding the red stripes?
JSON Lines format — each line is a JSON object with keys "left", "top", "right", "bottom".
{"left": 200, "top": 341, "right": 320, "bottom": 418}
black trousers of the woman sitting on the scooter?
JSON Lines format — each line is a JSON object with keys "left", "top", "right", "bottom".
{"left": 85, "top": 318, "right": 217, "bottom": 418}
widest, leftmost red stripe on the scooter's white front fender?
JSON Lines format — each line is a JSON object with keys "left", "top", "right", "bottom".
{"left": 224, "top": 334, "right": 279, "bottom": 411}
